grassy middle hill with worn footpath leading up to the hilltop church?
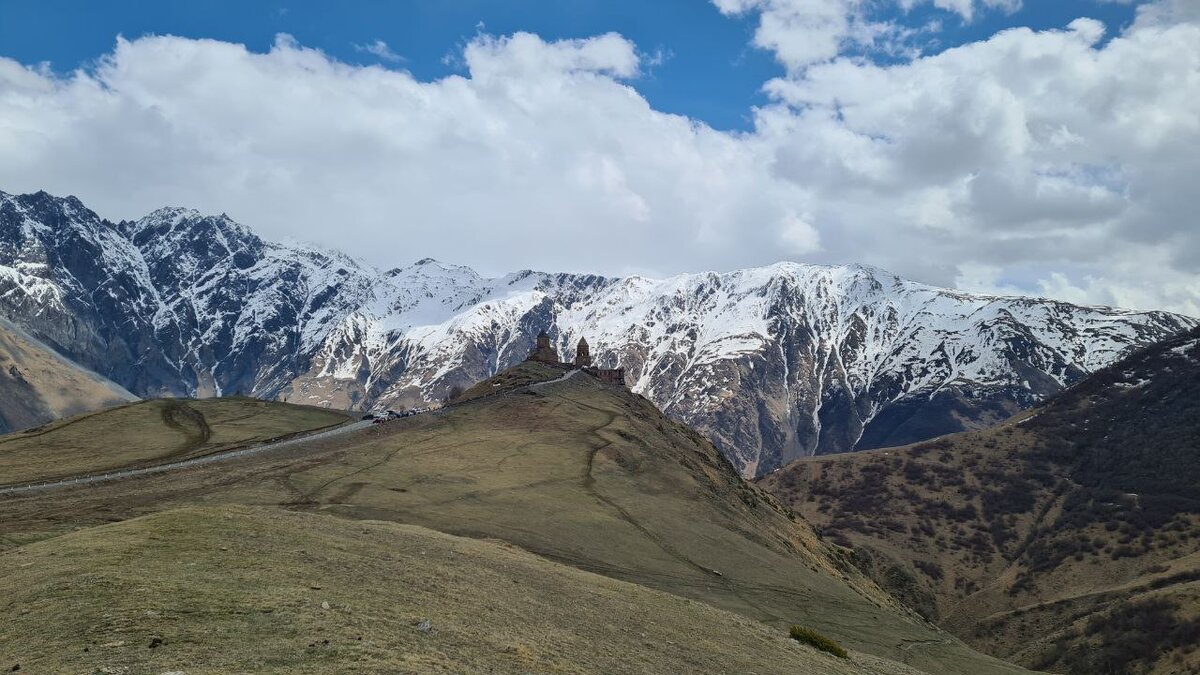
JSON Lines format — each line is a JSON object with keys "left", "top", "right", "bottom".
{"left": 0, "top": 365, "right": 1021, "bottom": 675}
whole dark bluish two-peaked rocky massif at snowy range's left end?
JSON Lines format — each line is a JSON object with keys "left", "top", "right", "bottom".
{"left": 0, "top": 193, "right": 371, "bottom": 396}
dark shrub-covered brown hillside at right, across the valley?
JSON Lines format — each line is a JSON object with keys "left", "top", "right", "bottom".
{"left": 760, "top": 331, "right": 1200, "bottom": 674}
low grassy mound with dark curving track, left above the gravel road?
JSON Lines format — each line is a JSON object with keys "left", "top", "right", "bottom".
{"left": 0, "top": 399, "right": 349, "bottom": 485}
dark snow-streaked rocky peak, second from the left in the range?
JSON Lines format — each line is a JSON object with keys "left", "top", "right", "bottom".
{"left": 121, "top": 204, "right": 373, "bottom": 396}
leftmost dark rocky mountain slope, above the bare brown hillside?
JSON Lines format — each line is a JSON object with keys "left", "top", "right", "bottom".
{"left": 0, "top": 192, "right": 182, "bottom": 395}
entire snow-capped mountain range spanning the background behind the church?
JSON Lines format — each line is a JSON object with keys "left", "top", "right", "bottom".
{"left": 0, "top": 186, "right": 1198, "bottom": 476}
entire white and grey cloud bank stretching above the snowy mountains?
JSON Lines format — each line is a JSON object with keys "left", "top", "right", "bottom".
{"left": 0, "top": 0, "right": 1200, "bottom": 315}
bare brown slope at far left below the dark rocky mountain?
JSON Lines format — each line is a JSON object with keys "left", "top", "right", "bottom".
{"left": 0, "top": 318, "right": 137, "bottom": 429}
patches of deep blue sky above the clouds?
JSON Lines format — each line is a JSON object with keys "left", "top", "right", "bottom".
{"left": 0, "top": 0, "right": 1136, "bottom": 130}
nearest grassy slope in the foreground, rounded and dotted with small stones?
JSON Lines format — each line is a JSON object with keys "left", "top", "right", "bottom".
{"left": 0, "top": 507, "right": 921, "bottom": 675}
